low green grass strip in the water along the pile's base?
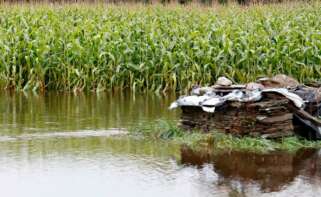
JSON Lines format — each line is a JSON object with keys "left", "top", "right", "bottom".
{"left": 130, "top": 120, "right": 321, "bottom": 152}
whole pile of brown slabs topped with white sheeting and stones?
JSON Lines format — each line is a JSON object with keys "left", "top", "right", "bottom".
{"left": 170, "top": 74, "right": 321, "bottom": 140}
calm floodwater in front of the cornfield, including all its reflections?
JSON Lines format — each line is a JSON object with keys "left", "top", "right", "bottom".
{"left": 0, "top": 93, "right": 321, "bottom": 197}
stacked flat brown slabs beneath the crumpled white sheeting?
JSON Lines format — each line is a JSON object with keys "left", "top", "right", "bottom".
{"left": 181, "top": 99, "right": 293, "bottom": 137}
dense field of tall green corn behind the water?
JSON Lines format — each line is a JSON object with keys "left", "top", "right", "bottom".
{"left": 0, "top": 3, "right": 321, "bottom": 91}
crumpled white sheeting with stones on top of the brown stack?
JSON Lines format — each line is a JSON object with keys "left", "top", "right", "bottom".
{"left": 169, "top": 75, "right": 305, "bottom": 113}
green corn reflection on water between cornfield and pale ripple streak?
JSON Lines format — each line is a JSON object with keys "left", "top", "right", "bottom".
{"left": 0, "top": 92, "right": 177, "bottom": 135}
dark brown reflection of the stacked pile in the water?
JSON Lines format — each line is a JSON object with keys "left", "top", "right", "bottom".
{"left": 181, "top": 146, "right": 321, "bottom": 195}
